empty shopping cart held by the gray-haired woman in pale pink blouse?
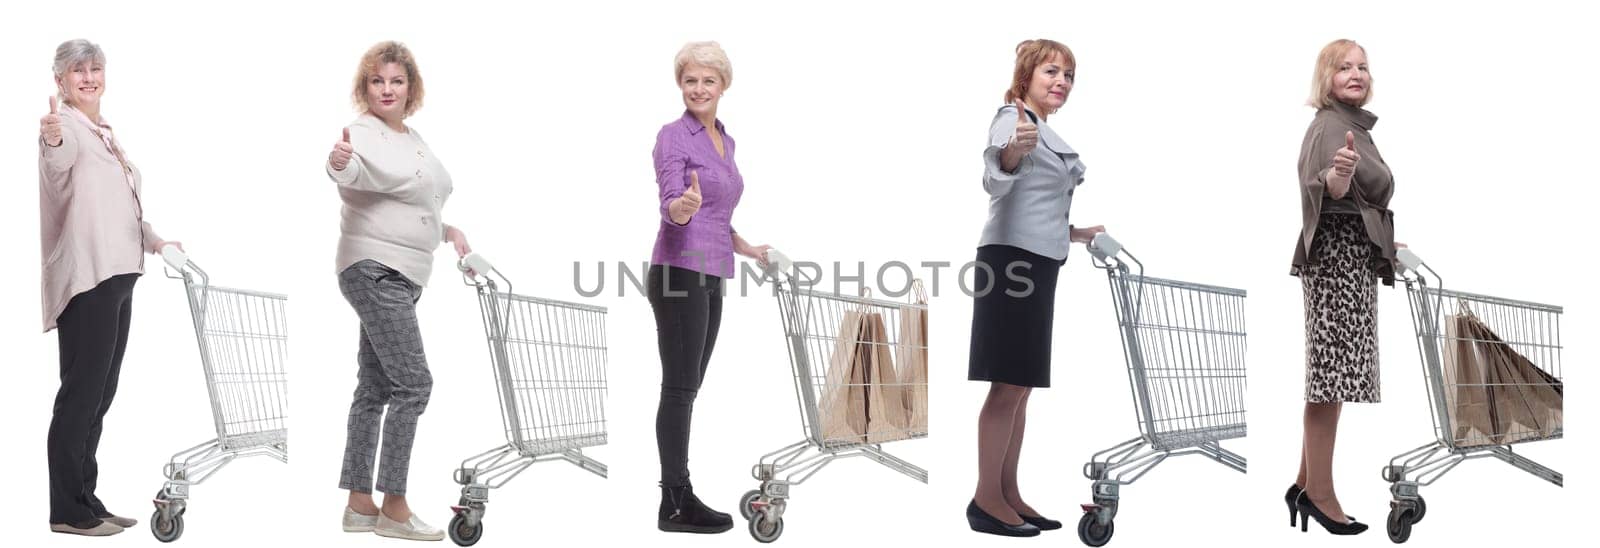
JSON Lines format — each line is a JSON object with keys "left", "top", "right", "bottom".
{"left": 150, "top": 245, "right": 290, "bottom": 542}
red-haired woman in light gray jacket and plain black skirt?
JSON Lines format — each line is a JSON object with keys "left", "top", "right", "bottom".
{"left": 966, "top": 40, "right": 1104, "bottom": 537}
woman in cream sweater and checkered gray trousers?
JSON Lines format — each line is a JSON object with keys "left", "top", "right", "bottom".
{"left": 326, "top": 42, "right": 470, "bottom": 540}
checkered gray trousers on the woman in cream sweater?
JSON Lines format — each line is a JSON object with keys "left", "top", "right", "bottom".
{"left": 339, "top": 260, "right": 434, "bottom": 495}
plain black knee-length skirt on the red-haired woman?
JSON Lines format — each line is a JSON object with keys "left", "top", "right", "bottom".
{"left": 966, "top": 245, "right": 1066, "bottom": 388}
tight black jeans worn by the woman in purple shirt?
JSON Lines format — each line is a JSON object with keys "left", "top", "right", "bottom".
{"left": 645, "top": 264, "right": 723, "bottom": 487}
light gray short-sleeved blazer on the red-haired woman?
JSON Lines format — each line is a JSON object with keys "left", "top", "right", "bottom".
{"left": 978, "top": 104, "right": 1083, "bottom": 261}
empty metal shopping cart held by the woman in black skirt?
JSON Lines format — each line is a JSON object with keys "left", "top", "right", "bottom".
{"left": 1078, "top": 232, "right": 1245, "bottom": 546}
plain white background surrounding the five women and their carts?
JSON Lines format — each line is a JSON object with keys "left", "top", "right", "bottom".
{"left": 0, "top": 2, "right": 1600, "bottom": 546}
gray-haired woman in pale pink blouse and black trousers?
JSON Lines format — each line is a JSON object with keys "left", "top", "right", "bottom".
{"left": 38, "top": 40, "right": 182, "bottom": 537}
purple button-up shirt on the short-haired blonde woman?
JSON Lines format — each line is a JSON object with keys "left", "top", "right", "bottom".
{"left": 650, "top": 111, "right": 744, "bottom": 279}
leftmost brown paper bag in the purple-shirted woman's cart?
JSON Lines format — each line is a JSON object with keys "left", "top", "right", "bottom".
{"left": 818, "top": 311, "right": 867, "bottom": 442}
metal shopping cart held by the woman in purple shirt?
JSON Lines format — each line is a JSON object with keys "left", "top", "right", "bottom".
{"left": 739, "top": 250, "right": 928, "bottom": 543}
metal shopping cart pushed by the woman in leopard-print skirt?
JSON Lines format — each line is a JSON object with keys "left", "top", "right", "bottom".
{"left": 1382, "top": 248, "right": 1562, "bottom": 543}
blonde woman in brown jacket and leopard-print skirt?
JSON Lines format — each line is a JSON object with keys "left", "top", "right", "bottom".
{"left": 1285, "top": 40, "right": 1397, "bottom": 535}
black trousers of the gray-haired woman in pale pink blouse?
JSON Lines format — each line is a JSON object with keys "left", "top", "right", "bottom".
{"left": 46, "top": 274, "right": 139, "bottom": 524}
